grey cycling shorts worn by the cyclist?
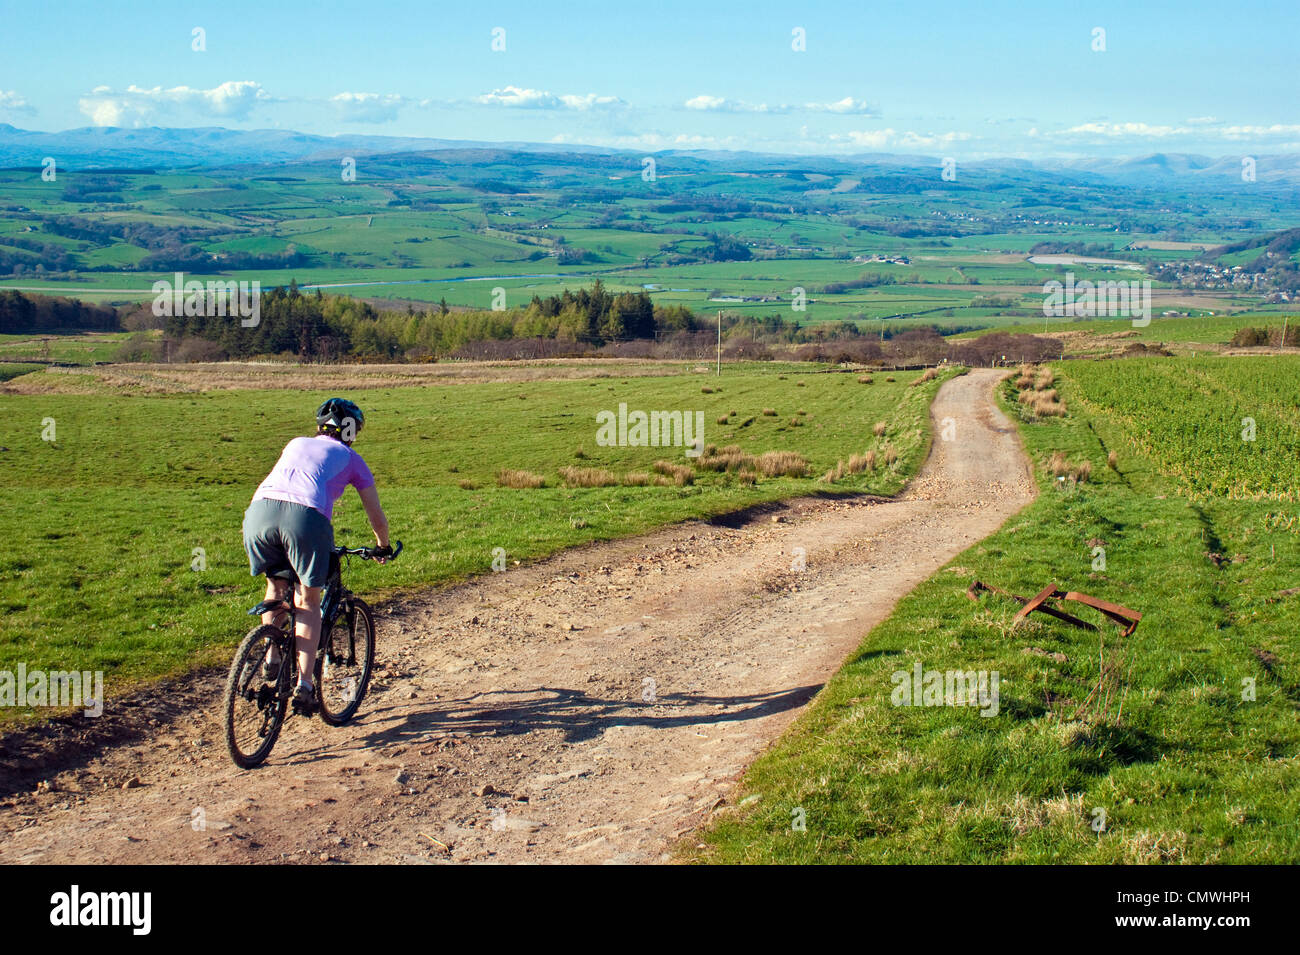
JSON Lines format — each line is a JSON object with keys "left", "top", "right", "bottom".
{"left": 244, "top": 498, "right": 334, "bottom": 587}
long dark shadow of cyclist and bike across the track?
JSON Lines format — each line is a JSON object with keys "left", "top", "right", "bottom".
{"left": 280, "top": 683, "right": 822, "bottom": 761}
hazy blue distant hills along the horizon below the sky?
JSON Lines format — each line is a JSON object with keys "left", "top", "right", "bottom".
{"left": 0, "top": 123, "right": 1300, "bottom": 191}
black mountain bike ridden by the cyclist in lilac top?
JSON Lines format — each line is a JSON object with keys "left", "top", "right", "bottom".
{"left": 222, "top": 541, "right": 402, "bottom": 769}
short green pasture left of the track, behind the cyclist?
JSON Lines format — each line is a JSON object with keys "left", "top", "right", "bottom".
{"left": 0, "top": 365, "right": 950, "bottom": 719}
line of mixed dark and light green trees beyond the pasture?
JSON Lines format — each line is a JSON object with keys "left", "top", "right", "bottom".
{"left": 152, "top": 281, "right": 1061, "bottom": 364}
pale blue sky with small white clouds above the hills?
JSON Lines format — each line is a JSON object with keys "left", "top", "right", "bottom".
{"left": 0, "top": 0, "right": 1300, "bottom": 159}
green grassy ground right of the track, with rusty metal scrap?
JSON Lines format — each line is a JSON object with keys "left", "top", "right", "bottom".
{"left": 684, "top": 357, "right": 1300, "bottom": 864}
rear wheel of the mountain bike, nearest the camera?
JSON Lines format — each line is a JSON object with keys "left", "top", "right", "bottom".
{"left": 221, "top": 624, "right": 293, "bottom": 769}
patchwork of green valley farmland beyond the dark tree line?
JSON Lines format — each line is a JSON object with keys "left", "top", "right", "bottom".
{"left": 0, "top": 151, "right": 1291, "bottom": 340}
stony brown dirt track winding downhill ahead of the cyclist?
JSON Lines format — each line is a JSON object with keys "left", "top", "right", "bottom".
{"left": 0, "top": 370, "right": 1034, "bottom": 863}
